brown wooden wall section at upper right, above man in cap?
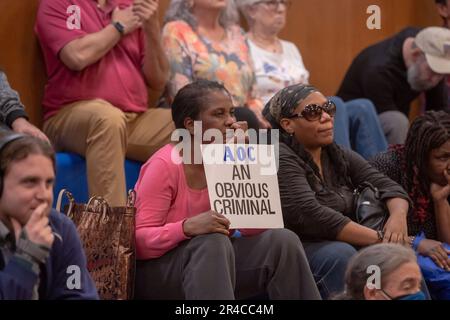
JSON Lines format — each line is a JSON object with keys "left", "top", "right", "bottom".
{"left": 282, "top": 0, "right": 441, "bottom": 94}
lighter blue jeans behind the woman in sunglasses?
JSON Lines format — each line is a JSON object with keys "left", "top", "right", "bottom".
{"left": 330, "top": 97, "right": 388, "bottom": 159}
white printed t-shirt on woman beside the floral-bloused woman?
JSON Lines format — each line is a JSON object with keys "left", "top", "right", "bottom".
{"left": 248, "top": 39, "right": 309, "bottom": 104}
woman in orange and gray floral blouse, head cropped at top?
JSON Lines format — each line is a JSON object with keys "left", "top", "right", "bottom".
{"left": 161, "top": 0, "right": 268, "bottom": 129}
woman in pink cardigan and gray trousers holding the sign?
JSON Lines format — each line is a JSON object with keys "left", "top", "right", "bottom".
{"left": 136, "top": 80, "right": 320, "bottom": 300}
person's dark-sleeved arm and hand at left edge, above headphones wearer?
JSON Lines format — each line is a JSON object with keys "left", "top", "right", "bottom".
{"left": 0, "top": 70, "right": 48, "bottom": 141}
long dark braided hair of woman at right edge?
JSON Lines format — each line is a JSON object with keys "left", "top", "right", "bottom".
{"left": 403, "top": 111, "right": 450, "bottom": 223}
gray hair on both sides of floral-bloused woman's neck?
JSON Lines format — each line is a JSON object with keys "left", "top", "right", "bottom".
{"left": 164, "top": 0, "right": 239, "bottom": 29}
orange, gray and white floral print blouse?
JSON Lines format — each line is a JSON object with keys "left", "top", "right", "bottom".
{"left": 160, "top": 20, "right": 262, "bottom": 110}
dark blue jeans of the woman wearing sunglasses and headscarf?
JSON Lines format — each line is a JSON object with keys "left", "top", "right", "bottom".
{"left": 303, "top": 241, "right": 356, "bottom": 300}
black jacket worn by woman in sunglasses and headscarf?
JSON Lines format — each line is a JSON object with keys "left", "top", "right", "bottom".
{"left": 278, "top": 143, "right": 410, "bottom": 241}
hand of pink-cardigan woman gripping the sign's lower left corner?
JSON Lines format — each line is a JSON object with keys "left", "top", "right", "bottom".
{"left": 183, "top": 210, "right": 230, "bottom": 237}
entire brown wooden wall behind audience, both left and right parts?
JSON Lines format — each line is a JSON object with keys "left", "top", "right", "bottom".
{"left": 0, "top": 0, "right": 442, "bottom": 125}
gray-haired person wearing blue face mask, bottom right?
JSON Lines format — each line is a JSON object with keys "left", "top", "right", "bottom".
{"left": 336, "top": 243, "right": 426, "bottom": 300}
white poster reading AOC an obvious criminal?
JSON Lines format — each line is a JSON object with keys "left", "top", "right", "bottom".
{"left": 202, "top": 144, "right": 284, "bottom": 229}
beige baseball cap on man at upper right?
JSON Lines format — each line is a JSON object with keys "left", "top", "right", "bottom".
{"left": 415, "top": 27, "right": 450, "bottom": 74}
